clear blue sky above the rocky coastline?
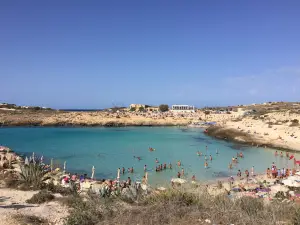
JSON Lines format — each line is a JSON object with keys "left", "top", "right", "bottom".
{"left": 0, "top": 0, "right": 300, "bottom": 108}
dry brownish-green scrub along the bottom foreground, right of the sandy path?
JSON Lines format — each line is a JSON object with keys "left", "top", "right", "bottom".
{"left": 66, "top": 189, "right": 300, "bottom": 225}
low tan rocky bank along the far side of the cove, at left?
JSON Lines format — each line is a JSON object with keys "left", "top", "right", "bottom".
{"left": 0, "top": 110, "right": 192, "bottom": 127}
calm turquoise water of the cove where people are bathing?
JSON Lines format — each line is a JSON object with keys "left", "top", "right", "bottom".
{"left": 0, "top": 127, "right": 300, "bottom": 184}
